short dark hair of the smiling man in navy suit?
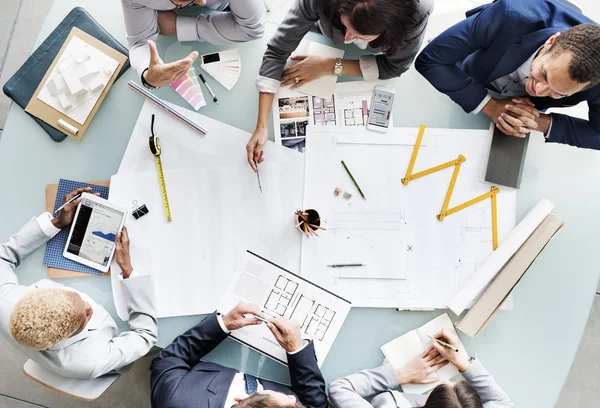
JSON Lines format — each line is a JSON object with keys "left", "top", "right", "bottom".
{"left": 548, "top": 24, "right": 600, "bottom": 86}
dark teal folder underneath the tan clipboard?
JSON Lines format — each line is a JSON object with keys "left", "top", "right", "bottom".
{"left": 3, "top": 7, "right": 129, "bottom": 142}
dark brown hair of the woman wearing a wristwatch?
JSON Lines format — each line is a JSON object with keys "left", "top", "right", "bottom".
{"left": 325, "top": 0, "right": 418, "bottom": 53}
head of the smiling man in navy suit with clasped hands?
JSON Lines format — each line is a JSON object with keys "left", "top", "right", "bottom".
{"left": 525, "top": 24, "right": 600, "bottom": 99}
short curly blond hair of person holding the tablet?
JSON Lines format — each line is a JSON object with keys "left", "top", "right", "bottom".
{"left": 8, "top": 288, "right": 81, "bottom": 350}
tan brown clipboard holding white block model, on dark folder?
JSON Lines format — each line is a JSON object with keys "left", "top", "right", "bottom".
{"left": 25, "top": 27, "right": 127, "bottom": 141}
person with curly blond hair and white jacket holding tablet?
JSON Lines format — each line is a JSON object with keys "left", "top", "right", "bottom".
{"left": 0, "top": 188, "right": 158, "bottom": 379}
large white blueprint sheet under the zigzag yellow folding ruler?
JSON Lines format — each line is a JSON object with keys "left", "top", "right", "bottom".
{"left": 301, "top": 126, "right": 516, "bottom": 309}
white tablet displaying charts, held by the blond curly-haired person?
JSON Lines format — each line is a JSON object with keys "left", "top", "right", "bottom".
{"left": 63, "top": 193, "right": 127, "bottom": 272}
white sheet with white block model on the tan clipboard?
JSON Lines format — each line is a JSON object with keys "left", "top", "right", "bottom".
{"left": 37, "top": 36, "right": 119, "bottom": 125}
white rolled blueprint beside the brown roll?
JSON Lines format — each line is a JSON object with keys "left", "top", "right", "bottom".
{"left": 448, "top": 198, "right": 554, "bottom": 316}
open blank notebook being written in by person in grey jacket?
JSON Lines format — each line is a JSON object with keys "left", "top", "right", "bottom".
{"left": 381, "top": 313, "right": 468, "bottom": 394}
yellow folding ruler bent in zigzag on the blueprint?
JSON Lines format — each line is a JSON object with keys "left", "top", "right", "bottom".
{"left": 402, "top": 125, "right": 500, "bottom": 250}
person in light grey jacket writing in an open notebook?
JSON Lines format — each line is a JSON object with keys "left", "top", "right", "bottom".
{"left": 329, "top": 330, "right": 514, "bottom": 408}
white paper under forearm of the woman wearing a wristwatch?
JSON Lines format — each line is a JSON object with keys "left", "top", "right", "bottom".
{"left": 284, "top": 38, "right": 344, "bottom": 98}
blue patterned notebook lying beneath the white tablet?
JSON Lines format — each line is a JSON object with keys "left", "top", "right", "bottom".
{"left": 42, "top": 179, "right": 108, "bottom": 275}
